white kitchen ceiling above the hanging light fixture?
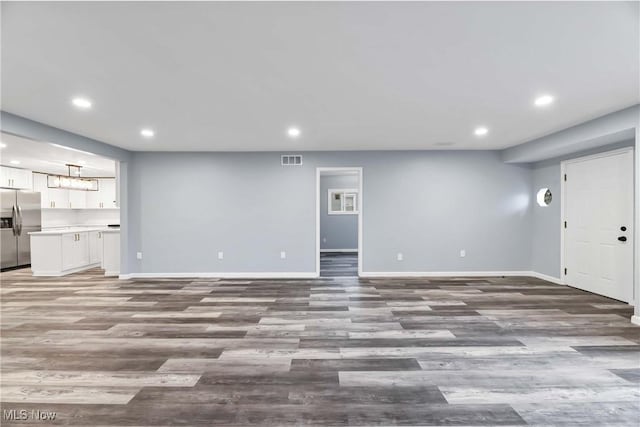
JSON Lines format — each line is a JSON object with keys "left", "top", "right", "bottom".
{"left": 0, "top": 133, "right": 116, "bottom": 177}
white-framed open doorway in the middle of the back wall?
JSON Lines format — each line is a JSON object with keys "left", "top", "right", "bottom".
{"left": 316, "top": 167, "right": 363, "bottom": 277}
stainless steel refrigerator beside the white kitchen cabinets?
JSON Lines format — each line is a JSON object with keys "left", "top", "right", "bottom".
{"left": 0, "top": 189, "right": 42, "bottom": 270}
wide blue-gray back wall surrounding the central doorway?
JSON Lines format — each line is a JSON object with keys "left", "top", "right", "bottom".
{"left": 123, "top": 151, "right": 532, "bottom": 273}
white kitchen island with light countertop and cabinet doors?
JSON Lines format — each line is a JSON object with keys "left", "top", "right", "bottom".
{"left": 29, "top": 226, "right": 120, "bottom": 276}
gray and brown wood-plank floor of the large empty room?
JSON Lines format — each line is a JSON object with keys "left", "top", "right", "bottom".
{"left": 1, "top": 270, "right": 640, "bottom": 426}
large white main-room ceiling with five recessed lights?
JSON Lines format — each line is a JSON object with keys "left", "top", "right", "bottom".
{"left": 1, "top": 2, "right": 640, "bottom": 151}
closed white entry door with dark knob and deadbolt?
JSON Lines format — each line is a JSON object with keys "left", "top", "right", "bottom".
{"left": 564, "top": 150, "right": 633, "bottom": 302}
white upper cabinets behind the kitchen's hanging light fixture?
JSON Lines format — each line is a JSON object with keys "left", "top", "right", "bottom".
{"left": 33, "top": 173, "right": 117, "bottom": 209}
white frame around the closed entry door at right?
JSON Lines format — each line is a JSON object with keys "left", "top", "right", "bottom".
{"left": 560, "top": 146, "right": 640, "bottom": 305}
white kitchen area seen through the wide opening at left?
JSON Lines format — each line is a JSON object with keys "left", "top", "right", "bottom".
{"left": 0, "top": 133, "right": 120, "bottom": 276}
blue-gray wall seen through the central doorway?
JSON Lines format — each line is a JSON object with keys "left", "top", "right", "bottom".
{"left": 320, "top": 175, "right": 358, "bottom": 249}
